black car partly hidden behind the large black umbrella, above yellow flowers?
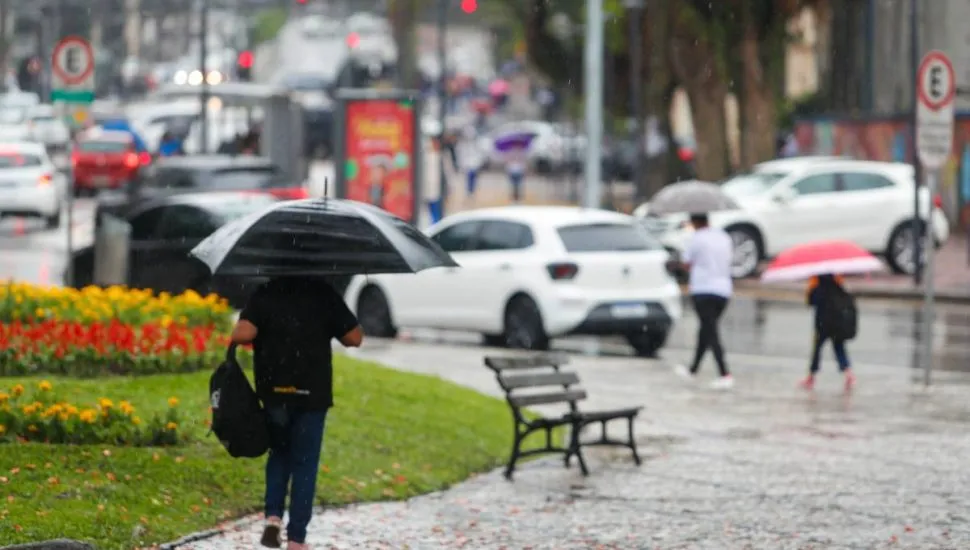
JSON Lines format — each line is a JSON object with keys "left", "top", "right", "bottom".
{"left": 71, "top": 192, "right": 276, "bottom": 307}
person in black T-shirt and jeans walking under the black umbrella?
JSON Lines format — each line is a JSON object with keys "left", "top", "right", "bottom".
{"left": 232, "top": 277, "right": 364, "bottom": 550}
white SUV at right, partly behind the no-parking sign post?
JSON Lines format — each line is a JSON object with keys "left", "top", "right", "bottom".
{"left": 652, "top": 157, "right": 950, "bottom": 277}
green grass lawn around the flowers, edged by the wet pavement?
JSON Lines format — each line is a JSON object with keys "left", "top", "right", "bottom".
{"left": 0, "top": 357, "right": 536, "bottom": 550}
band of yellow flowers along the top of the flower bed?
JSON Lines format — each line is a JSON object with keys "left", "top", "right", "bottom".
{"left": 0, "top": 282, "right": 230, "bottom": 328}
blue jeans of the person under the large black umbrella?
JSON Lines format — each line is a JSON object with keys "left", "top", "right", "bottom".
{"left": 264, "top": 406, "right": 327, "bottom": 543}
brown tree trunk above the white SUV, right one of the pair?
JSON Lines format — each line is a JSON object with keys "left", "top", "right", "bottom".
{"left": 738, "top": 17, "right": 784, "bottom": 169}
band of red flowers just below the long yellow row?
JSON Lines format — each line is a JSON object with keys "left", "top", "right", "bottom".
{"left": 0, "top": 320, "right": 228, "bottom": 377}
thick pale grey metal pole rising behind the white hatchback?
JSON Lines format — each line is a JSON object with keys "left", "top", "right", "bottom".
{"left": 583, "top": 0, "right": 603, "bottom": 208}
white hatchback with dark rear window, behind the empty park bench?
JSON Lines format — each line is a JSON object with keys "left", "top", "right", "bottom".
{"left": 345, "top": 206, "right": 681, "bottom": 356}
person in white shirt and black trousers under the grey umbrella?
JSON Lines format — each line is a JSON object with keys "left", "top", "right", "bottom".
{"left": 676, "top": 214, "right": 734, "bottom": 390}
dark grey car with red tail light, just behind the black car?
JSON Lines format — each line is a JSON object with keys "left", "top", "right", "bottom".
{"left": 140, "top": 155, "right": 310, "bottom": 199}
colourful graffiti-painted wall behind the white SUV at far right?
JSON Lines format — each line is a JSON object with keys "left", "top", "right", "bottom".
{"left": 795, "top": 114, "right": 970, "bottom": 228}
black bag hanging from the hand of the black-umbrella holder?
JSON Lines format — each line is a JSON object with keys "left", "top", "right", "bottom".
{"left": 209, "top": 344, "right": 270, "bottom": 458}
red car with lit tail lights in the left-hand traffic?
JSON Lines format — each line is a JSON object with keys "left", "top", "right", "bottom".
{"left": 71, "top": 130, "right": 152, "bottom": 194}
